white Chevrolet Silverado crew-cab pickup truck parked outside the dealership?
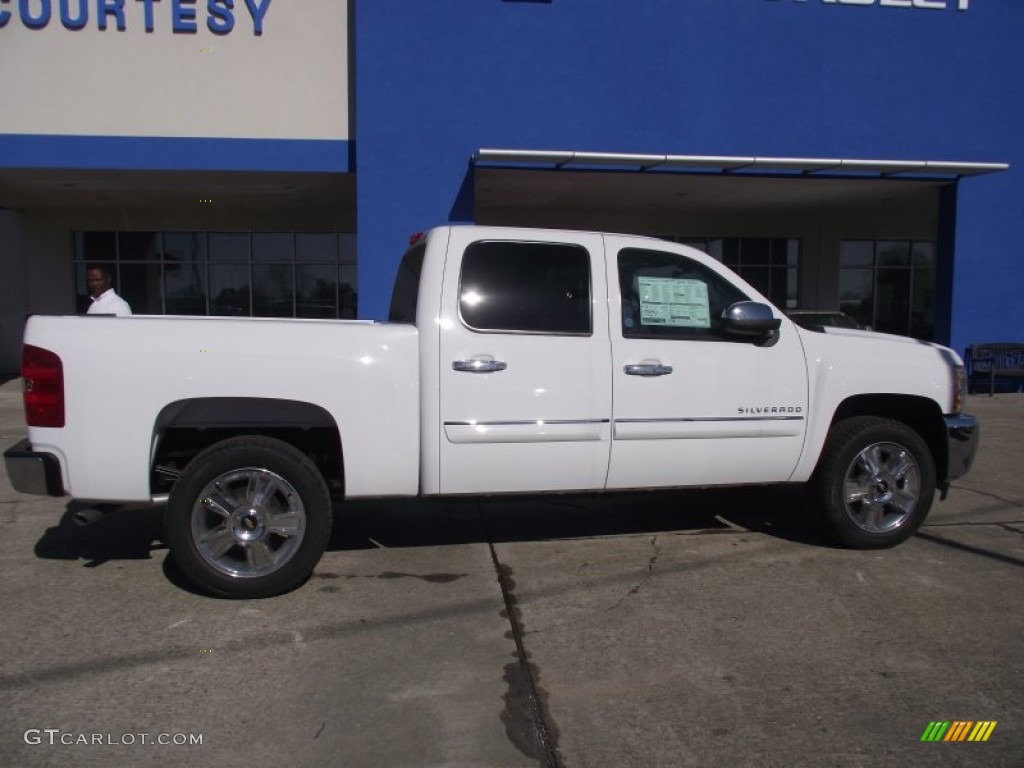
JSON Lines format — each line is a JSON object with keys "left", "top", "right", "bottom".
{"left": 5, "top": 226, "right": 979, "bottom": 597}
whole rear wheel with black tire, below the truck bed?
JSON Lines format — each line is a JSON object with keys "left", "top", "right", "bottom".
{"left": 165, "top": 436, "right": 332, "bottom": 598}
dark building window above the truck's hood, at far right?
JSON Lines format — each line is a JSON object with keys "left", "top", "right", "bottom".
{"left": 839, "top": 240, "right": 936, "bottom": 340}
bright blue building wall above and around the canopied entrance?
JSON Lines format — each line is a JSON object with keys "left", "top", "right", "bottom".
{"left": 353, "top": 0, "right": 1024, "bottom": 349}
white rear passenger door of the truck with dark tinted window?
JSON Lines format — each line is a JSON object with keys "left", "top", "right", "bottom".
{"left": 438, "top": 227, "right": 611, "bottom": 494}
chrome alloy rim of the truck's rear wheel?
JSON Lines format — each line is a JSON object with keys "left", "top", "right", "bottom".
{"left": 191, "top": 467, "right": 306, "bottom": 579}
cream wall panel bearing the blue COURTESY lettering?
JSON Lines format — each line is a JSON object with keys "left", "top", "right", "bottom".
{"left": 0, "top": 0, "right": 349, "bottom": 140}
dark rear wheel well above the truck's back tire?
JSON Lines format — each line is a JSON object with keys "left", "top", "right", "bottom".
{"left": 150, "top": 397, "right": 344, "bottom": 496}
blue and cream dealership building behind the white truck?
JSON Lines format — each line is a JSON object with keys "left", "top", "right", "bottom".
{"left": 0, "top": 0, "right": 1024, "bottom": 373}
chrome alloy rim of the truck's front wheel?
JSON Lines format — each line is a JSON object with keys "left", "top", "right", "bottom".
{"left": 843, "top": 442, "right": 922, "bottom": 534}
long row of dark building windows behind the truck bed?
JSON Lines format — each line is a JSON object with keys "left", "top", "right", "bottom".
{"left": 74, "top": 231, "right": 356, "bottom": 317}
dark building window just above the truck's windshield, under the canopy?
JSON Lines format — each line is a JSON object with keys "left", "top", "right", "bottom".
{"left": 673, "top": 238, "right": 800, "bottom": 309}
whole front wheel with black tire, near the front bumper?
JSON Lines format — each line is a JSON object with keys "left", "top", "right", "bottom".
{"left": 813, "top": 417, "right": 935, "bottom": 549}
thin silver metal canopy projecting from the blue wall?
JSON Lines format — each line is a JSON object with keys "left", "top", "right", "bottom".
{"left": 473, "top": 150, "right": 1010, "bottom": 178}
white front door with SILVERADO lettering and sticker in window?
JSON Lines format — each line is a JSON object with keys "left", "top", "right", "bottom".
{"left": 606, "top": 236, "right": 807, "bottom": 488}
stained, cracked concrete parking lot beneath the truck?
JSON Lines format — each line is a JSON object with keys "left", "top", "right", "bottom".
{"left": 0, "top": 381, "right": 1024, "bottom": 768}
